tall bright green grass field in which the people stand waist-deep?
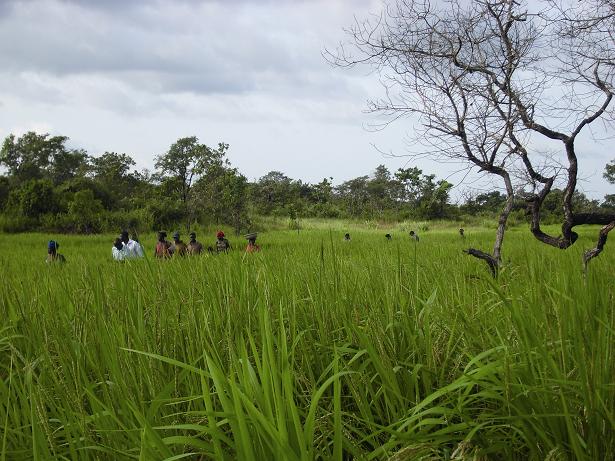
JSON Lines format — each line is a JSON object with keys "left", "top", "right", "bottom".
{"left": 0, "top": 229, "right": 615, "bottom": 460}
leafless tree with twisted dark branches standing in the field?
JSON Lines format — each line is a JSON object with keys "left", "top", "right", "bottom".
{"left": 327, "top": 0, "right": 615, "bottom": 275}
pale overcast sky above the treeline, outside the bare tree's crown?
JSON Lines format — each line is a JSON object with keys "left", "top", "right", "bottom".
{"left": 0, "top": 0, "right": 615, "bottom": 198}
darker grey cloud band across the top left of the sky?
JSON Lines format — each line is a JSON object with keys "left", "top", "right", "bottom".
{"left": 0, "top": 0, "right": 370, "bottom": 101}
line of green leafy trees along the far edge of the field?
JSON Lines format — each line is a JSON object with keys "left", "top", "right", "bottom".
{"left": 0, "top": 132, "right": 615, "bottom": 233}
